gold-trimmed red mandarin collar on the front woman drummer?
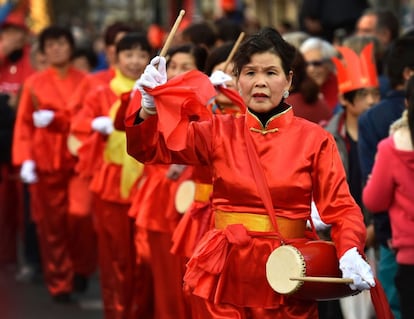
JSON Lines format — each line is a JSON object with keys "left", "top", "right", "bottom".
{"left": 246, "top": 106, "right": 294, "bottom": 135}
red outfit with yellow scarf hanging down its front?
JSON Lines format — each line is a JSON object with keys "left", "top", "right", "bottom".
{"left": 72, "top": 71, "right": 146, "bottom": 319}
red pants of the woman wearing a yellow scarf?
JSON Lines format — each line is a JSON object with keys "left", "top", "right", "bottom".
{"left": 94, "top": 197, "right": 139, "bottom": 319}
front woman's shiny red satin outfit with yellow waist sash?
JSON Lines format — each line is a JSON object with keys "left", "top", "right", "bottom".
{"left": 126, "top": 103, "right": 365, "bottom": 318}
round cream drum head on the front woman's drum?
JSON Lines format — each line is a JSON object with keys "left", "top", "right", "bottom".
{"left": 266, "top": 245, "right": 306, "bottom": 295}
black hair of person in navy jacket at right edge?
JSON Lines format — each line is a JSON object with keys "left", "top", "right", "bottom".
{"left": 385, "top": 36, "right": 414, "bottom": 89}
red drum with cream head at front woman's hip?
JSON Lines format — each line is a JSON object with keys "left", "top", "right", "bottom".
{"left": 266, "top": 240, "right": 359, "bottom": 300}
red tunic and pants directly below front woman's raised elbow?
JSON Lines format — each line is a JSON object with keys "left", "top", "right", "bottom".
{"left": 130, "top": 164, "right": 192, "bottom": 319}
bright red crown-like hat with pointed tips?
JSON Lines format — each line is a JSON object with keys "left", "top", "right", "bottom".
{"left": 332, "top": 43, "right": 379, "bottom": 93}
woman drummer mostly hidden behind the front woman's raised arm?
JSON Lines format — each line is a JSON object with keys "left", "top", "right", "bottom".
{"left": 171, "top": 42, "right": 242, "bottom": 258}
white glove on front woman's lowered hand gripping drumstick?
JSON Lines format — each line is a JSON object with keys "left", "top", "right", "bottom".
{"left": 339, "top": 247, "right": 375, "bottom": 290}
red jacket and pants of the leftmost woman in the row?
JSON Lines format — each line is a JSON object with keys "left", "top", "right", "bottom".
{"left": 13, "top": 68, "right": 91, "bottom": 295}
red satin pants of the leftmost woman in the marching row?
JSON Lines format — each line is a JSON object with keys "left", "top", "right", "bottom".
{"left": 30, "top": 172, "right": 96, "bottom": 295}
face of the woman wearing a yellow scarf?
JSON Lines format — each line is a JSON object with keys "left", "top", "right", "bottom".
{"left": 117, "top": 47, "right": 150, "bottom": 80}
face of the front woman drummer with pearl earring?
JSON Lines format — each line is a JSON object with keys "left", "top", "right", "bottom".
{"left": 237, "top": 52, "right": 292, "bottom": 113}
